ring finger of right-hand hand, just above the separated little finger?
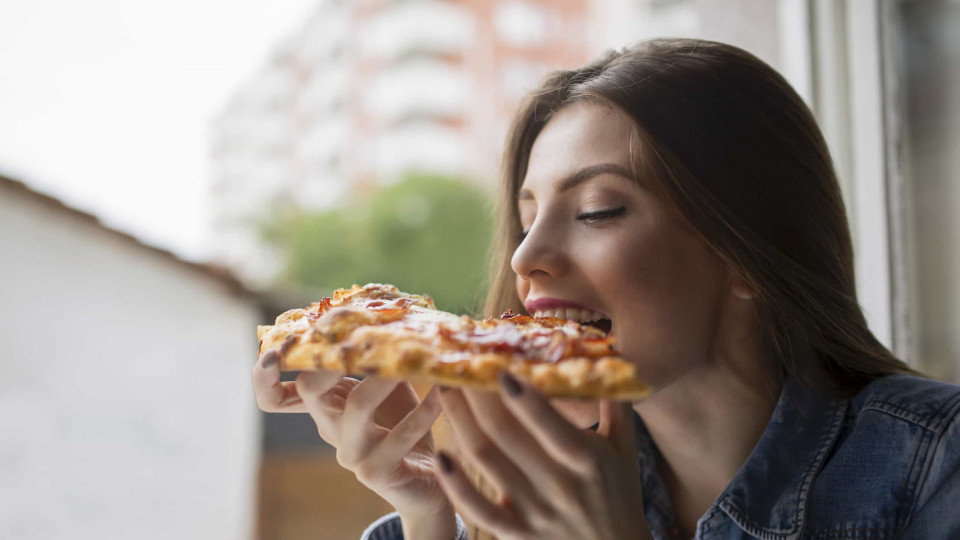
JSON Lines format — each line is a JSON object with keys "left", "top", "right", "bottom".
{"left": 440, "top": 389, "right": 540, "bottom": 507}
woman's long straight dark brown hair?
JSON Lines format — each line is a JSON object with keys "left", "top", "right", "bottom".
{"left": 484, "top": 39, "right": 915, "bottom": 397}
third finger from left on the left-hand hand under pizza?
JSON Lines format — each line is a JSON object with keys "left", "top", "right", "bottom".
{"left": 338, "top": 376, "right": 400, "bottom": 460}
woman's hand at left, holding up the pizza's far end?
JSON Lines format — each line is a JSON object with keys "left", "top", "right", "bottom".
{"left": 252, "top": 349, "right": 456, "bottom": 539}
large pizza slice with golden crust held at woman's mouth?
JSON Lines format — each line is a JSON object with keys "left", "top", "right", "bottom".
{"left": 257, "top": 283, "right": 650, "bottom": 399}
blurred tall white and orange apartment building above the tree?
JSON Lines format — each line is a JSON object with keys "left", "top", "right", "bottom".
{"left": 211, "top": 0, "right": 589, "bottom": 285}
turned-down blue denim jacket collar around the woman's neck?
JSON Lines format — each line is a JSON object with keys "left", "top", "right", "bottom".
{"left": 634, "top": 379, "right": 848, "bottom": 540}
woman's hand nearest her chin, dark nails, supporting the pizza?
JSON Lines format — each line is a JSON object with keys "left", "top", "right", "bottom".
{"left": 437, "top": 376, "right": 652, "bottom": 540}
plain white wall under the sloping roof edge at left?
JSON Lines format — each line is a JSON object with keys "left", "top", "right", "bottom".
{"left": 0, "top": 185, "right": 260, "bottom": 540}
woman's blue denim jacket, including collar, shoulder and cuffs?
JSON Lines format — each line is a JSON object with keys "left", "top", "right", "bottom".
{"left": 362, "top": 375, "right": 960, "bottom": 540}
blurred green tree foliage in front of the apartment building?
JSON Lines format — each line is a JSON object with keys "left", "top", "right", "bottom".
{"left": 269, "top": 175, "right": 492, "bottom": 313}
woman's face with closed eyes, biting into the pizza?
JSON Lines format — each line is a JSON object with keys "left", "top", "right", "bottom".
{"left": 511, "top": 101, "right": 730, "bottom": 388}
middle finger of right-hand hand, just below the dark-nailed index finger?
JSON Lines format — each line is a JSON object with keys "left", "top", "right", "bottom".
{"left": 451, "top": 390, "right": 569, "bottom": 493}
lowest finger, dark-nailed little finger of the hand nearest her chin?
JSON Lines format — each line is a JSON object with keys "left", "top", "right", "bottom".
{"left": 437, "top": 452, "right": 524, "bottom": 538}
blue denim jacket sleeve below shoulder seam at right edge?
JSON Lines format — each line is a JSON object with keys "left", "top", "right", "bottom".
{"left": 903, "top": 406, "right": 960, "bottom": 539}
